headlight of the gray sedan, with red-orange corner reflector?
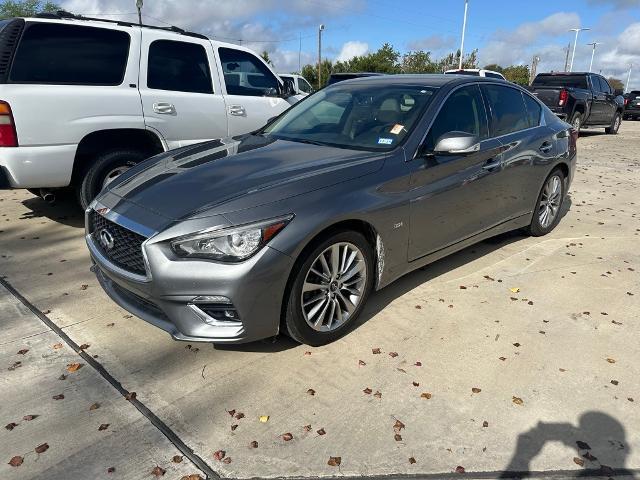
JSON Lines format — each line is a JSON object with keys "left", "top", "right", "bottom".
{"left": 171, "top": 215, "right": 293, "bottom": 262}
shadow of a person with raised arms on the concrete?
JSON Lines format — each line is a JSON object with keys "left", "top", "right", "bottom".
{"left": 499, "top": 411, "right": 638, "bottom": 479}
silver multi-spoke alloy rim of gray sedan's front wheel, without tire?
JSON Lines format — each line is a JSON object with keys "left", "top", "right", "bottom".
{"left": 301, "top": 242, "right": 368, "bottom": 332}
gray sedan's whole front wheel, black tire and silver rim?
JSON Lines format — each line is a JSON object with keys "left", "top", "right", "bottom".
{"left": 284, "top": 231, "right": 375, "bottom": 346}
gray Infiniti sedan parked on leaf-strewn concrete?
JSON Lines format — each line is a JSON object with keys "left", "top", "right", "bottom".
{"left": 86, "top": 75, "right": 577, "bottom": 345}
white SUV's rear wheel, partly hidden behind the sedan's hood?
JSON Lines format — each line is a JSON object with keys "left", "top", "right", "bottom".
{"left": 76, "top": 149, "right": 148, "bottom": 209}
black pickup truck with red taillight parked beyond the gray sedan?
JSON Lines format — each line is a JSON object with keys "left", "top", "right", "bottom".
{"left": 529, "top": 72, "right": 624, "bottom": 134}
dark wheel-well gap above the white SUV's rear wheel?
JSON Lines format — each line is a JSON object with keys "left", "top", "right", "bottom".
{"left": 71, "top": 128, "right": 166, "bottom": 185}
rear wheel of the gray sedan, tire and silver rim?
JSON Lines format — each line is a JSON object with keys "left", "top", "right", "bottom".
{"left": 528, "top": 169, "right": 565, "bottom": 237}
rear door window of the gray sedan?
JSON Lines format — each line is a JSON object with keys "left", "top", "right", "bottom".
{"left": 482, "top": 85, "right": 529, "bottom": 137}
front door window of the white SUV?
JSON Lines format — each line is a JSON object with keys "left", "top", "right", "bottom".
{"left": 218, "top": 48, "right": 279, "bottom": 97}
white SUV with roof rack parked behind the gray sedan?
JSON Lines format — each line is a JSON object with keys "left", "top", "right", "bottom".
{"left": 0, "top": 12, "right": 300, "bottom": 206}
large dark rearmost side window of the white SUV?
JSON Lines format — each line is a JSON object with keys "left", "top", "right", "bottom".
{"left": 9, "top": 23, "right": 130, "bottom": 85}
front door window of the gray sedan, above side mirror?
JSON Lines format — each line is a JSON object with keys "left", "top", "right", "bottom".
{"left": 425, "top": 85, "right": 488, "bottom": 151}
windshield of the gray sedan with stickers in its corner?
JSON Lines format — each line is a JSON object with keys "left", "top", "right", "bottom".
{"left": 261, "top": 83, "right": 436, "bottom": 151}
